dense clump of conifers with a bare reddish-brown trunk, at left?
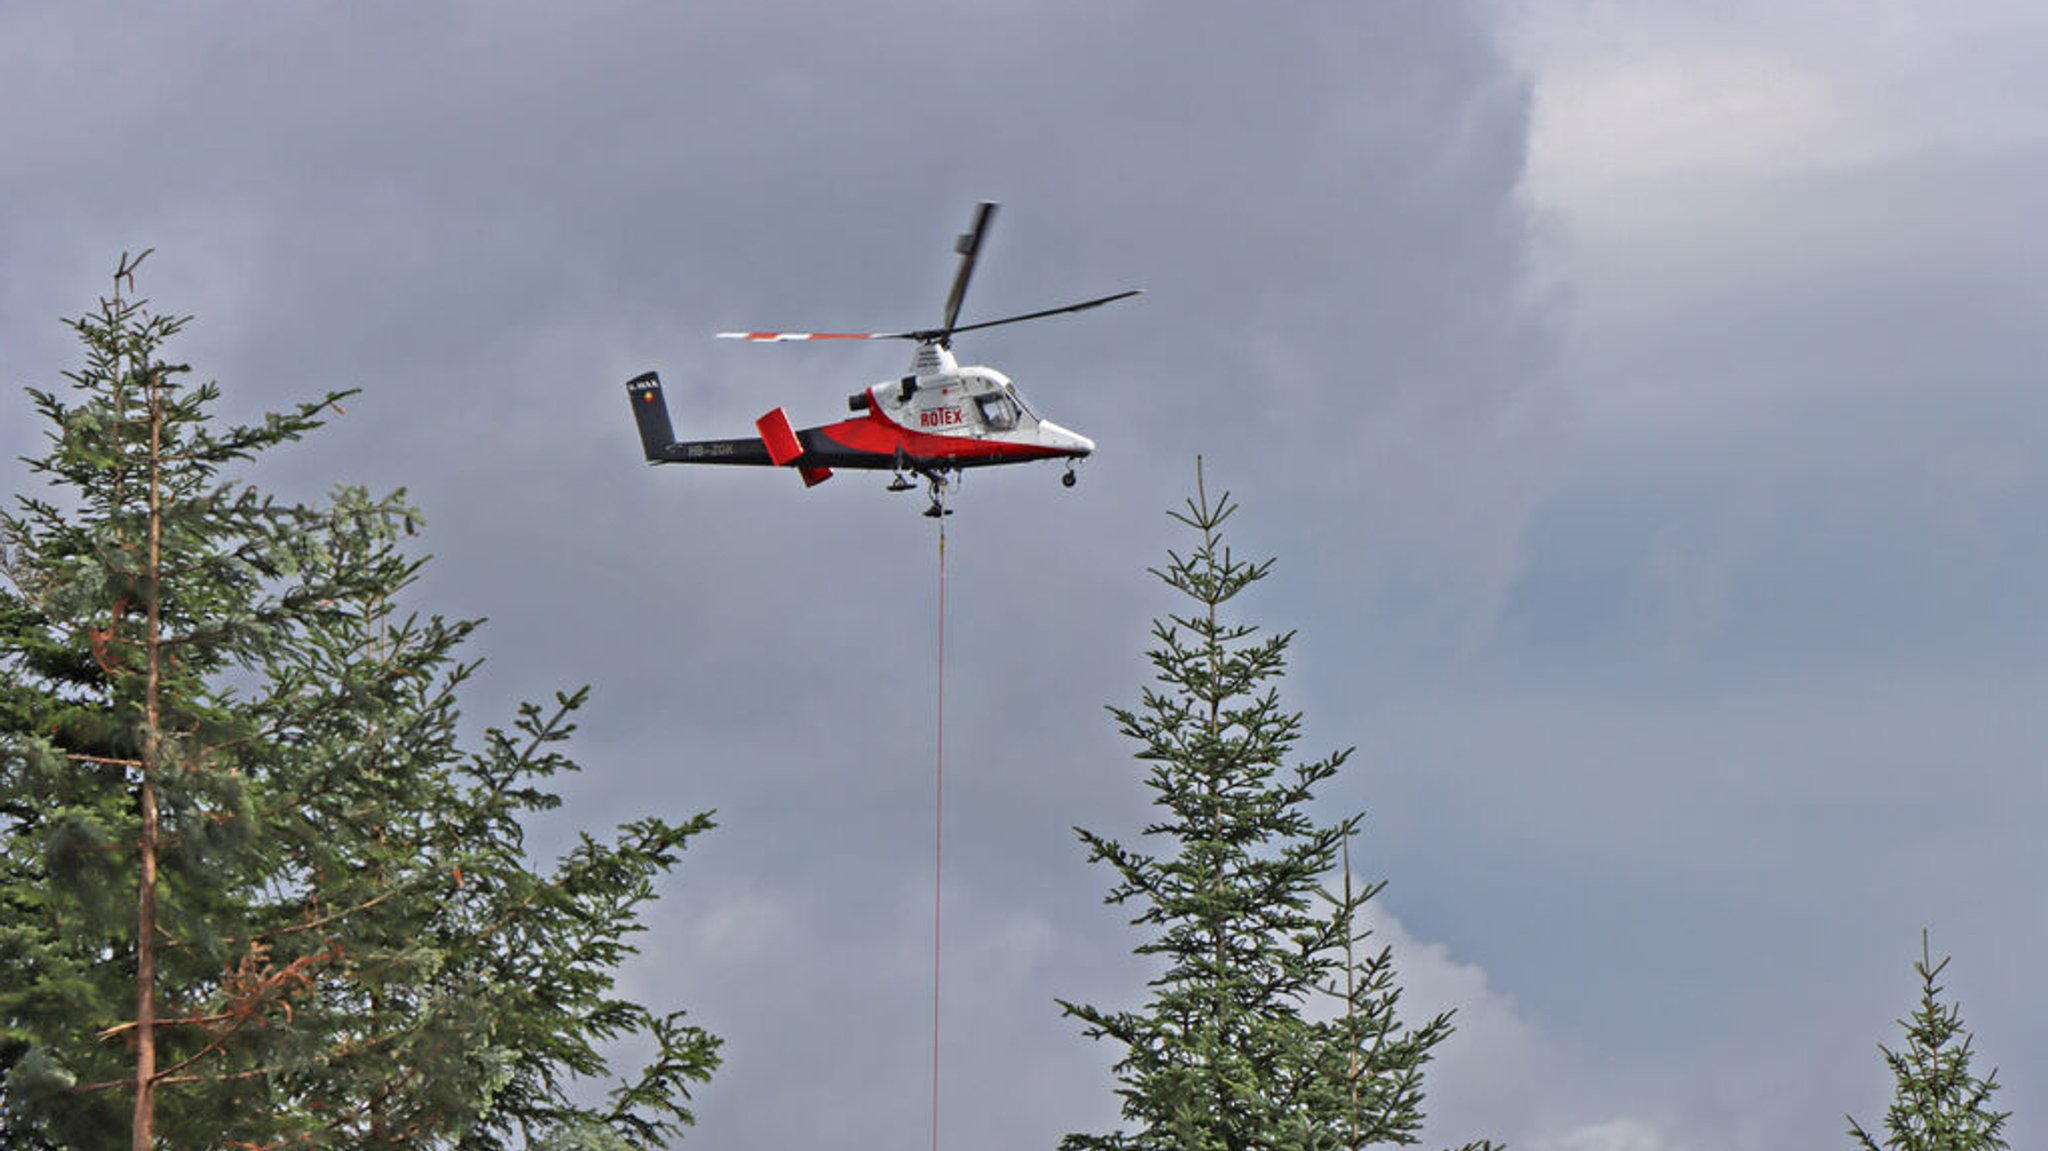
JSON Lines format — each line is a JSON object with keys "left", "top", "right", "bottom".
{"left": 0, "top": 258, "right": 717, "bottom": 1149}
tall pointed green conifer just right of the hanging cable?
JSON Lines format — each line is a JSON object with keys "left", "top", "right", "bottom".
{"left": 1061, "top": 465, "right": 1499, "bottom": 1151}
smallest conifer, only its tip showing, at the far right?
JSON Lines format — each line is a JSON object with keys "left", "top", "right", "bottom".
{"left": 1849, "top": 932, "right": 2011, "bottom": 1151}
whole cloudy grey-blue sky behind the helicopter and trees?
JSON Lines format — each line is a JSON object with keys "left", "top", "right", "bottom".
{"left": 0, "top": 0, "right": 2048, "bottom": 1151}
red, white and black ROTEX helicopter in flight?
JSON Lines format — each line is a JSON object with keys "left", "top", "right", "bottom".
{"left": 627, "top": 203, "right": 1139, "bottom": 516}
